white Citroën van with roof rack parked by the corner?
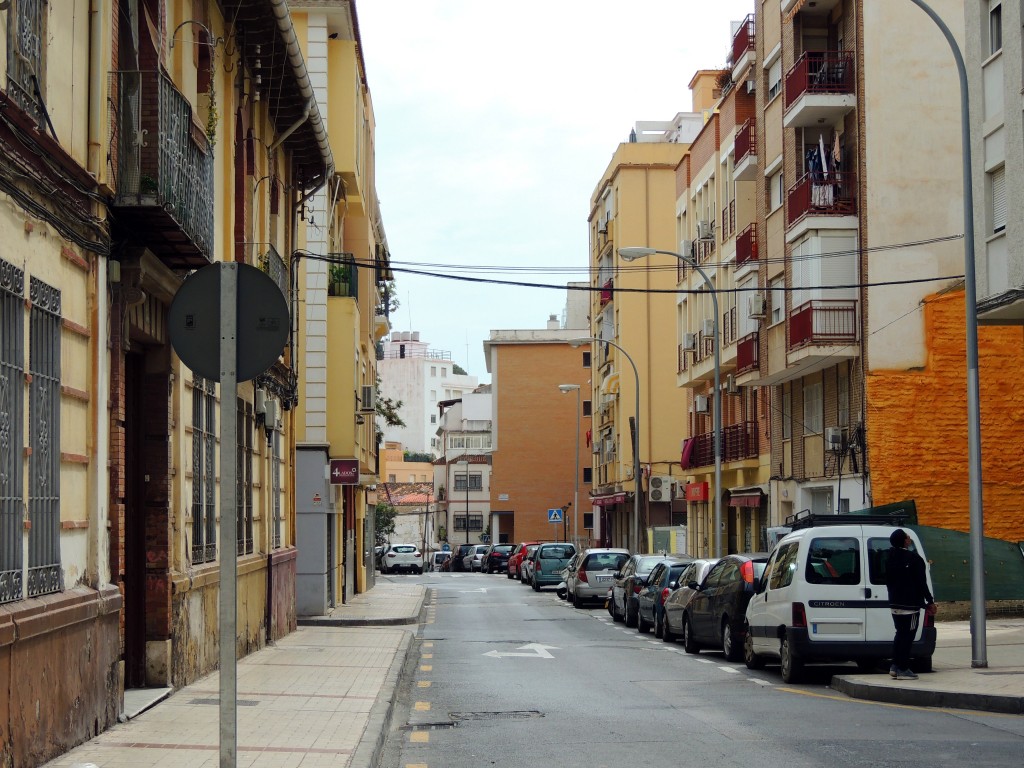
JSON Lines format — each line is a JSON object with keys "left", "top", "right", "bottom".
{"left": 743, "top": 515, "right": 935, "bottom": 683}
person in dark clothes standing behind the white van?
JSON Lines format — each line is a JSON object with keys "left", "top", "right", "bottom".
{"left": 886, "top": 528, "right": 936, "bottom": 680}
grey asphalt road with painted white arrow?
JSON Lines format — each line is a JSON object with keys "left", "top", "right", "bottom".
{"left": 381, "top": 573, "right": 1024, "bottom": 768}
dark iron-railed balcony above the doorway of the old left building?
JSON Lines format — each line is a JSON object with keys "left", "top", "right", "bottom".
{"left": 110, "top": 72, "right": 213, "bottom": 269}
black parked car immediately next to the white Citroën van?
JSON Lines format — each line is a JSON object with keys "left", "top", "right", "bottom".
{"left": 682, "top": 552, "right": 768, "bottom": 662}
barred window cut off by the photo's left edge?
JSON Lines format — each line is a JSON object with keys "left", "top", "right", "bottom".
{"left": 0, "top": 259, "right": 25, "bottom": 603}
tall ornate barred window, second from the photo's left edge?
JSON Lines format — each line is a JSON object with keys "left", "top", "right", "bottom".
{"left": 28, "top": 278, "right": 63, "bottom": 597}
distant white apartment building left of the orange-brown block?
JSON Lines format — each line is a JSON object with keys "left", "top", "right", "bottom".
{"left": 378, "top": 331, "right": 478, "bottom": 458}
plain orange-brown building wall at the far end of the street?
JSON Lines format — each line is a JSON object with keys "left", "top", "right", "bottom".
{"left": 490, "top": 343, "right": 591, "bottom": 542}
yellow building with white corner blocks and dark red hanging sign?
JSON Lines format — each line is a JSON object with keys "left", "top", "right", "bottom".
{"left": 293, "top": 2, "right": 391, "bottom": 614}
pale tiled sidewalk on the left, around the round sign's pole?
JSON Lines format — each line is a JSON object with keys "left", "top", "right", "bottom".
{"left": 45, "top": 580, "right": 425, "bottom": 768}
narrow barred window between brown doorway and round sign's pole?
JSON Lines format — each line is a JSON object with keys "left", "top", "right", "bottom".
{"left": 191, "top": 376, "right": 217, "bottom": 563}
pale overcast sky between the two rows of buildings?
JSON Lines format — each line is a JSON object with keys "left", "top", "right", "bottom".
{"left": 356, "top": 0, "right": 754, "bottom": 382}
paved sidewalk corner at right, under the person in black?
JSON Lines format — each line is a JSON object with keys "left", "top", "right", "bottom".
{"left": 831, "top": 617, "right": 1024, "bottom": 715}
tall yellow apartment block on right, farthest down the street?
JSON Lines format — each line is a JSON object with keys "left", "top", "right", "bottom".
{"left": 589, "top": 124, "right": 702, "bottom": 551}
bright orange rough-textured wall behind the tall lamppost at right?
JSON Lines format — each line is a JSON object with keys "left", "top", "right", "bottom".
{"left": 866, "top": 292, "right": 1024, "bottom": 542}
